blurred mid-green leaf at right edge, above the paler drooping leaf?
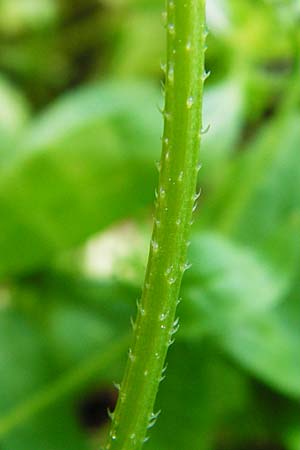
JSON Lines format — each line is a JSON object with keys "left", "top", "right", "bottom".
{"left": 208, "top": 114, "right": 300, "bottom": 270}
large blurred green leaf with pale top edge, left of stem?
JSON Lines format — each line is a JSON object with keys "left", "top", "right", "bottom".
{"left": 0, "top": 83, "right": 160, "bottom": 276}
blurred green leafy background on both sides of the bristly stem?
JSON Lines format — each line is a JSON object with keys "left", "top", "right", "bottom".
{"left": 0, "top": 0, "right": 300, "bottom": 450}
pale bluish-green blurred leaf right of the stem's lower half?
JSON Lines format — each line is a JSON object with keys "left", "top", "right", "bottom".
{"left": 183, "top": 234, "right": 300, "bottom": 398}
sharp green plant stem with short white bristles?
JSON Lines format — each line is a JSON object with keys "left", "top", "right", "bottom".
{"left": 105, "top": 0, "right": 207, "bottom": 450}
